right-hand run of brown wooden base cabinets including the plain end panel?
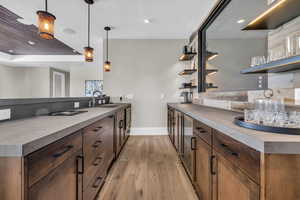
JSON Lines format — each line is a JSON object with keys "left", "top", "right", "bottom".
{"left": 168, "top": 107, "right": 300, "bottom": 200}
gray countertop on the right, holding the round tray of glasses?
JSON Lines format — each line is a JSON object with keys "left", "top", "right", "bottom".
{"left": 168, "top": 103, "right": 300, "bottom": 154}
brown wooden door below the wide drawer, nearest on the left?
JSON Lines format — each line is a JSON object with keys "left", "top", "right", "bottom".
{"left": 28, "top": 153, "right": 83, "bottom": 200}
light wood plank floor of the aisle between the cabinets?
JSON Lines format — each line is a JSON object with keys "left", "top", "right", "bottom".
{"left": 98, "top": 136, "right": 198, "bottom": 200}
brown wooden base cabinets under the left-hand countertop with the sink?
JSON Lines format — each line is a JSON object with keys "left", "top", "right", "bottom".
{"left": 0, "top": 108, "right": 131, "bottom": 200}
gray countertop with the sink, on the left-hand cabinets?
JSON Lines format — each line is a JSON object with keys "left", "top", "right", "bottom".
{"left": 0, "top": 104, "right": 128, "bottom": 157}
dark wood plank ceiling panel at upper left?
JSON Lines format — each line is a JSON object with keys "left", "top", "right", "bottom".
{"left": 0, "top": 5, "right": 80, "bottom": 55}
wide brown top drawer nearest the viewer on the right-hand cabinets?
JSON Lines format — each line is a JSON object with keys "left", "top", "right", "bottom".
{"left": 213, "top": 130, "right": 260, "bottom": 184}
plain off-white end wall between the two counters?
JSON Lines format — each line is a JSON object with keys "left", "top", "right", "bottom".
{"left": 104, "top": 39, "right": 185, "bottom": 134}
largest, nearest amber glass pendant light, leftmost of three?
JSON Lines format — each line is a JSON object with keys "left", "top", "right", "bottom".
{"left": 37, "top": 0, "right": 56, "bottom": 40}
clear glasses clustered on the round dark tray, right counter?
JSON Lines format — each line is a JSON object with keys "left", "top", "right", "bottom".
{"left": 244, "top": 99, "right": 300, "bottom": 128}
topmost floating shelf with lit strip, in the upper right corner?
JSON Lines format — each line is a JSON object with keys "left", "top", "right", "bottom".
{"left": 243, "top": 0, "right": 300, "bottom": 30}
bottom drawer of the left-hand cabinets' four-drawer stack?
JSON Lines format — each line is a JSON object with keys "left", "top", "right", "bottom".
{"left": 83, "top": 169, "right": 106, "bottom": 200}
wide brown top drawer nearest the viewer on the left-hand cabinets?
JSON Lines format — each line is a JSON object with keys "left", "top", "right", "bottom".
{"left": 27, "top": 132, "right": 82, "bottom": 187}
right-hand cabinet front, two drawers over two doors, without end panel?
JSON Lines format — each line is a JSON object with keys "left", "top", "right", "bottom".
{"left": 194, "top": 122, "right": 260, "bottom": 200}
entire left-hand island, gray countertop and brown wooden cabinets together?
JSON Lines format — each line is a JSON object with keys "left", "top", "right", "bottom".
{"left": 0, "top": 104, "right": 131, "bottom": 200}
